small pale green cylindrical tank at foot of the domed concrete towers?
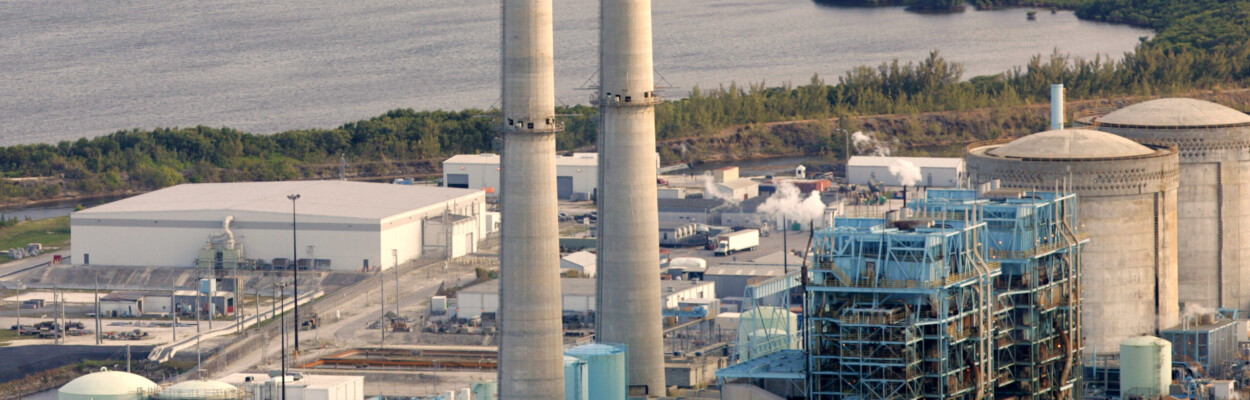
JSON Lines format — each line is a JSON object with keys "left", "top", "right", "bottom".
{"left": 1120, "top": 336, "right": 1171, "bottom": 399}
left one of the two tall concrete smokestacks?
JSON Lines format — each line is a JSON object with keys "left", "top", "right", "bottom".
{"left": 499, "top": 0, "right": 564, "bottom": 400}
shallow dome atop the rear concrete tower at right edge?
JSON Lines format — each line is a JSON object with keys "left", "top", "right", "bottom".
{"left": 1095, "top": 99, "right": 1250, "bottom": 128}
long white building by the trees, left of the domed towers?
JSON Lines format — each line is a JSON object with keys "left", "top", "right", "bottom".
{"left": 846, "top": 156, "right": 968, "bottom": 188}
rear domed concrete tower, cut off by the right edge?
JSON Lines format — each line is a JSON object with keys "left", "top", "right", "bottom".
{"left": 1081, "top": 99, "right": 1250, "bottom": 313}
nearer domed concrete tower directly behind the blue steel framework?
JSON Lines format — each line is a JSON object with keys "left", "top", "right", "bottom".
{"left": 965, "top": 129, "right": 1180, "bottom": 349}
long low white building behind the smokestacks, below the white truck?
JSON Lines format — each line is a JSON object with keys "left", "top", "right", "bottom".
{"left": 456, "top": 278, "right": 716, "bottom": 319}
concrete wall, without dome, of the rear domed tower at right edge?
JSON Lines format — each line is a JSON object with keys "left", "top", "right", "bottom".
{"left": 1095, "top": 125, "right": 1250, "bottom": 313}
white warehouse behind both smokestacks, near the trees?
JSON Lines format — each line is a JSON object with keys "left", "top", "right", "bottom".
{"left": 443, "top": 153, "right": 660, "bottom": 200}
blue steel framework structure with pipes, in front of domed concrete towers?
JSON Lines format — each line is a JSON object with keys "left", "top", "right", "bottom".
{"left": 808, "top": 190, "right": 1086, "bottom": 399}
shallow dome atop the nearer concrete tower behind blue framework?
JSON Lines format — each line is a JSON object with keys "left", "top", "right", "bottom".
{"left": 988, "top": 129, "right": 1155, "bottom": 159}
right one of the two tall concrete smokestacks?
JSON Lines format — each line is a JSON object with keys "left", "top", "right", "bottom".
{"left": 596, "top": 0, "right": 665, "bottom": 396}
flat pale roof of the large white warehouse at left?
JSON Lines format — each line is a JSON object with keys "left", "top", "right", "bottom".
{"left": 74, "top": 180, "right": 480, "bottom": 219}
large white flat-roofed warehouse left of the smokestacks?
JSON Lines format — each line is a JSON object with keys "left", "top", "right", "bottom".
{"left": 70, "top": 180, "right": 491, "bottom": 271}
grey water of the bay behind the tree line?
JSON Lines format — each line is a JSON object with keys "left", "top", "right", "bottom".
{"left": 0, "top": 0, "right": 1150, "bottom": 145}
